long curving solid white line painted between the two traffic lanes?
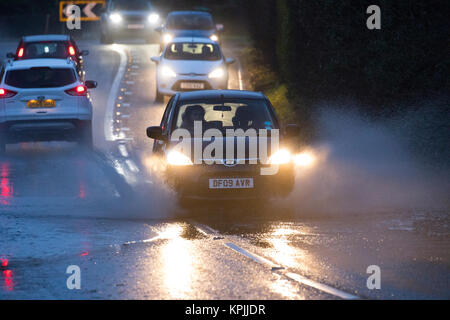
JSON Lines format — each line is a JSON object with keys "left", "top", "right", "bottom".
{"left": 104, "top": 45, "right": 127, "bottom": 141}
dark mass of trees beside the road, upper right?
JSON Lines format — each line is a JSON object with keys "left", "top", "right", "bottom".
{"left": 243, "top": 0, "right": 450, "bottom": 111}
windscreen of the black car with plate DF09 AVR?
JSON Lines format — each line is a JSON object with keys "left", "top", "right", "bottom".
{"left": 174, "top": 99, "right": 277, "bottom": 134}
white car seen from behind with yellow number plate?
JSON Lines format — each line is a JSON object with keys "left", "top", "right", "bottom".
{"left": 0, "top": 59, "right": 97, "bottom": 153}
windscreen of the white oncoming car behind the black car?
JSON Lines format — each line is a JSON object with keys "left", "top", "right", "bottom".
{"left": 164, "top": 42, "right": 222, "bottom": 61}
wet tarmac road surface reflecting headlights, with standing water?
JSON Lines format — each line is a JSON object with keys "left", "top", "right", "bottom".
{"left": 0, "top": 41, "right": 450, "bottom": 299}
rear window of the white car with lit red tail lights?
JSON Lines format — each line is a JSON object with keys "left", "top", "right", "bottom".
{"left": 5, "top": 67, "right": 77, "bottom": 89}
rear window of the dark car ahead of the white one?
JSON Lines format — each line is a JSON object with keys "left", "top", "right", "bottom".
{"left": 20, "top": 41, "right": 69, "bottom": 59}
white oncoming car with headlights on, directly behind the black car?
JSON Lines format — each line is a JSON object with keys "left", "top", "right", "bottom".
{"left": 151, "top": 37, "right": 234, "bottom": 102}
